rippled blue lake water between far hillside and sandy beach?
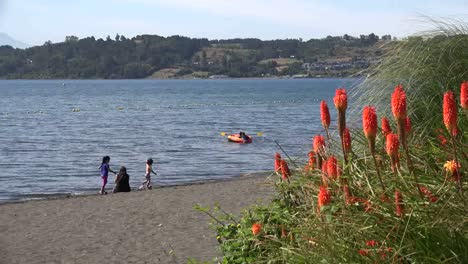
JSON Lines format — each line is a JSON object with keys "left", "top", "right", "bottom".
{"left": 0, "top": 79, "right": 356, "bottom": 202}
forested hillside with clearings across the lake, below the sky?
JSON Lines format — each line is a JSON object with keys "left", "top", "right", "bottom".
{"left": 0, "top": 34, "right": 391, "bottom": 79}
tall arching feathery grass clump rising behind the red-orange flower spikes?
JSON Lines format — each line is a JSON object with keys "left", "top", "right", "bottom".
{"left": 353, "top": 18, "right": 468, "bottom": 136}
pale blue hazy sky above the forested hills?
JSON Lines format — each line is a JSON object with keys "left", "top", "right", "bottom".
{"left": 0, "top": 0, "right": 468, "bottom": 45}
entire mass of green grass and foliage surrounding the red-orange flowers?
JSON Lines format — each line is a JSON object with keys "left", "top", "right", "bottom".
{"left": 199, "top": 21, "right": 468, "bottom": 263}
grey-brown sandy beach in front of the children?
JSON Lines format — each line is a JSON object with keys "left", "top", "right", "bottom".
{"left": 0, "top": 174, "right": 273, "bottom": 264}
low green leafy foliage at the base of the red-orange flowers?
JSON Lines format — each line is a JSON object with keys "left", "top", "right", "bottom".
{"left": 203, "top": 123, "right": 468, "bottom": 263}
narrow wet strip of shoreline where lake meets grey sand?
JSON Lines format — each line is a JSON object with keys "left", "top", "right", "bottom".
{"left": 0, "top": 171, "right": 273, "bottom": 207}
